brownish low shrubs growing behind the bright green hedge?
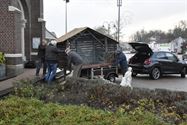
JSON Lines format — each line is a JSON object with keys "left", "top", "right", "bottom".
{"left": 11, "top": 78, "right": 187, "bottom": 125}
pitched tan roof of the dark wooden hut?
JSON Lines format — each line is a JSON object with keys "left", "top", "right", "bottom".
{"left": 56, "top": 27, "right": 117, "bottom": 42}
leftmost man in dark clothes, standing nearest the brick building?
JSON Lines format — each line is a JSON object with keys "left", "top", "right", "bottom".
{"left": 36, "top": 40, "right": 47, "bottom": 76}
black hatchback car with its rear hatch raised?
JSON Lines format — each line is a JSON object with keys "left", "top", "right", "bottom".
{"left": 128, "top": 43, "right": 187, "bottom": 80}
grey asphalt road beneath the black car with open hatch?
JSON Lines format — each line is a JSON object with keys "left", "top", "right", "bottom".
{"left": 117, "top": 74, "right": 187, "bottom": 92}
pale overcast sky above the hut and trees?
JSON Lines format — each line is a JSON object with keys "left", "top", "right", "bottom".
{"left": 43, "top": 0, "right": 187, "bottom": 41}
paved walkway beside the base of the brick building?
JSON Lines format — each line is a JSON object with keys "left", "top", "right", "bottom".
{"left": 0, "top": 69, "right": 36, "bottom": 96}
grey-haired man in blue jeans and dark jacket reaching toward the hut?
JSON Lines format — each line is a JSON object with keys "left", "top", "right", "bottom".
{"left": 44, "top": 40, "right": 64, "bottom": 84}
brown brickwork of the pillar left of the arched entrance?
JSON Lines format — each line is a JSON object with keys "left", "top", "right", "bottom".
{"left": 0, "top": 0, "right": 23, "bottom": 76}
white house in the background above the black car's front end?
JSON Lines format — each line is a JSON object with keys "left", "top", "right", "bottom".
{"left": 171, "top": 37, "right": 186, "bottom": 53}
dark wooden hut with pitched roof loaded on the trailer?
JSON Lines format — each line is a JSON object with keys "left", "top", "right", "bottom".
{"left": 57, "top": 27, "right": 118, "bottom": 64}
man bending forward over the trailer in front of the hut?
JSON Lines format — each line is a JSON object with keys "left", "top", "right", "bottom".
{"left": 65, "top": 47, "right": 84, "bottom": 78}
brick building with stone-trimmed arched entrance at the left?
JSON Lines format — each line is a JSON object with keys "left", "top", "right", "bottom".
{"left": 0, "top": 0, "right": 45, "bottom": 76}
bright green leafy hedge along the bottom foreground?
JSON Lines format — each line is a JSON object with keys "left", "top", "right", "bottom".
{"left": 0, "top": 96, "right": 166, "bottom": 125}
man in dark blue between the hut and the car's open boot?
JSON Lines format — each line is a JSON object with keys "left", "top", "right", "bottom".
{"left": 114, "top": 47, "right": 128, "bottom": 76}
